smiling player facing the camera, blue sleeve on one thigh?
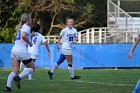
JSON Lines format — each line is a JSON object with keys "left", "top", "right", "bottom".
{"left": 48, "top": 18, "right": 81, "bottom": 80}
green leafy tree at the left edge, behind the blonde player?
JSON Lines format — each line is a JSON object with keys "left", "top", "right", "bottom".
{"left": 0, "top": 0, "right": 22, "bottom": 43}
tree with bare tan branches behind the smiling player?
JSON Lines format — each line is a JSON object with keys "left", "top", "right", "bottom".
{"left": 19, "top": 0, "right": 94, "bottom": 35}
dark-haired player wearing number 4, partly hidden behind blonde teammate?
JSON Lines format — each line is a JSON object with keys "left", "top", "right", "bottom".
{"left": 25, "top": 24, "right": 50, "bottom": 80}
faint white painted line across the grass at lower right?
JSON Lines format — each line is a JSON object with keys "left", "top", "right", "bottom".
{"left": 62, "top": 80, "right": 134, "bottom": 86}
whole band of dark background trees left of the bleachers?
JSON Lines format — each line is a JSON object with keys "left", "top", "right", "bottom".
{"left": 0, "top": 0, "right": 106, "bottom": 43}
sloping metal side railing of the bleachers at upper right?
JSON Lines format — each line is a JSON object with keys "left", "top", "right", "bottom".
{"left": 107, "top": 0, "right": 135, "bottom": 30}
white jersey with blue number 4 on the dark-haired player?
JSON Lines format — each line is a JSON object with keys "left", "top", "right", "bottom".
{"left": 28, "top": 32, "right": 46, "bottom": 55}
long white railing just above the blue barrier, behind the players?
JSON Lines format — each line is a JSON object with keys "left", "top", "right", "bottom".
{"left": 45, "top": 27, "right": 140, "bottom": 43}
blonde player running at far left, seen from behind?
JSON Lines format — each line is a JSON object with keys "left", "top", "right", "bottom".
{"left": 4, "top": 13, "right": 35, "bottom": 91}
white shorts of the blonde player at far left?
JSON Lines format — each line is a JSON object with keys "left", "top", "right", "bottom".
{"left": 11, "top": 51, "right": 30, "bottom": 61}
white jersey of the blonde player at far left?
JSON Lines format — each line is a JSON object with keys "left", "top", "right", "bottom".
{"left": 12, "top": 24, "right": 30, "bottom": 53}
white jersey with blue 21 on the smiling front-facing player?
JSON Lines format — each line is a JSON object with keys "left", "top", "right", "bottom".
{"left": 60, "top": 27, "right": 77, "bottom": 49}
